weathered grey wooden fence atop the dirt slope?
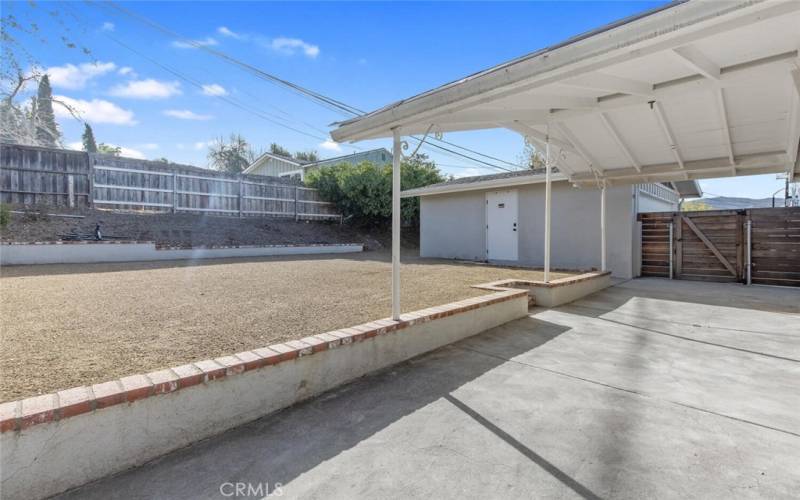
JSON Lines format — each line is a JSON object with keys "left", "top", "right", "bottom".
{"left": 0, "top": 144, "right": 341, "bottom": 219}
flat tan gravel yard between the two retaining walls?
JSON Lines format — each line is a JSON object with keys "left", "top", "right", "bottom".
{"left": 0, "top": 252, "right": 576, "bottom": 401}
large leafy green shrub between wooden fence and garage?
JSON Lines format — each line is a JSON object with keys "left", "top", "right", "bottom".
{"left": 306, "top": 155, "right": 445, "bottom": 227}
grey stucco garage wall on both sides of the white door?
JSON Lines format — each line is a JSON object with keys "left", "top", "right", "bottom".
{"left": 420, "top": 182, "right": 635, "bottom": 278}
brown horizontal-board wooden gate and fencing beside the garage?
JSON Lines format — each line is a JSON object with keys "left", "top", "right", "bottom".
{"left": 639, "top": 207, "right": 800, "bottom": 286}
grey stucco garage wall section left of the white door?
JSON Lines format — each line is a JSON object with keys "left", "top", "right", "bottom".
{"left": 419, "top": 191, "right": 486, "bottom": 260}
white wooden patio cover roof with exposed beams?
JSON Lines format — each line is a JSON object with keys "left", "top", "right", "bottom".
{"left": 332, "top": 2, "right": 800, "bottom": 185}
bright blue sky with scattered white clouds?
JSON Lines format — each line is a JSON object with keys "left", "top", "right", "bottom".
{"left": 2, "top": 2, "right": 782, "bottom": 197}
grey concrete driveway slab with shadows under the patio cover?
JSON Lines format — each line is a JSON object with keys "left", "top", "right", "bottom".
{"left": 59, "top": 279, "right": 800, "bottom": 499}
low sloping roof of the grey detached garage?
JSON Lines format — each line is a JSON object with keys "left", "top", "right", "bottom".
{"left": 400, "top": 169, "right": 702, "bottom": 198}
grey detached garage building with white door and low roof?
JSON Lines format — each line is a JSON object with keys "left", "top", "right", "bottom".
{"left": 402, "top": 171, "right": 702, "bottom": 278}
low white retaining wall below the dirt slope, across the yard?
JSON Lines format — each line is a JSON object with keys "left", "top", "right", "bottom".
{"left": 0, "top": 241, "right": 364, "bottom": 266}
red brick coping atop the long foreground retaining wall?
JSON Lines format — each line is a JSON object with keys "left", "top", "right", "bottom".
{"left": 0, "top": 289, "right": 527, "bottom": 432}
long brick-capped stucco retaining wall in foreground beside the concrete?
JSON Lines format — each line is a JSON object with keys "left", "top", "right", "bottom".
{"left": 0, "top": 290, "right": 528, "bottom": 499}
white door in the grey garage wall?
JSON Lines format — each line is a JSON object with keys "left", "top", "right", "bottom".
{"left": 486, "top": 189, "right": 519, "bottom": 260}
